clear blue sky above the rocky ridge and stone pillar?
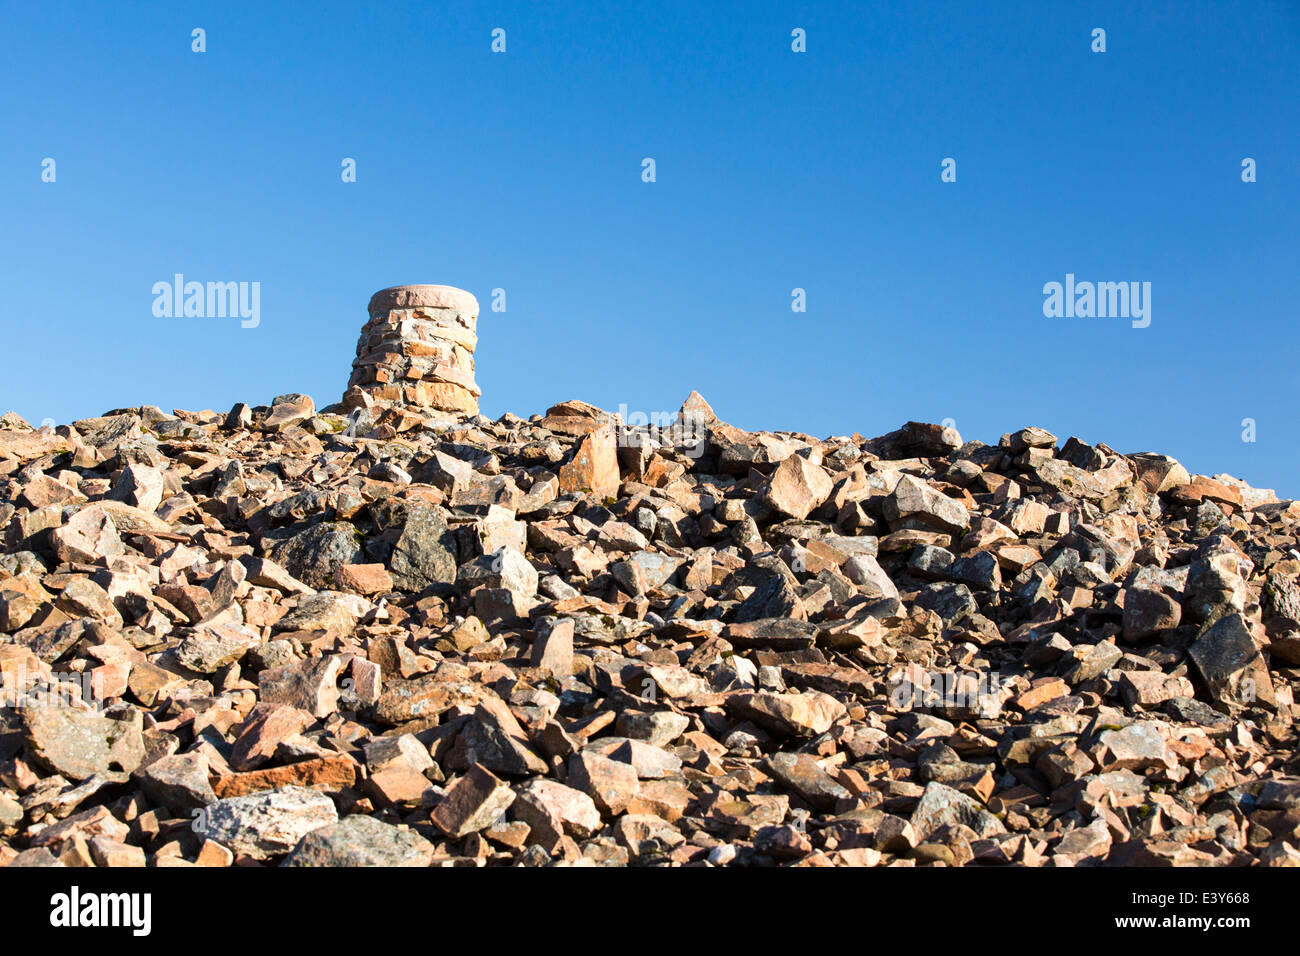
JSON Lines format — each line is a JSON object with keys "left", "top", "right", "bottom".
{"left": 0, "top": 0, "right": 1300, "bottom": 496}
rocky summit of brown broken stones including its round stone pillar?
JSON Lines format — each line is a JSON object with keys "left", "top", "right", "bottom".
{"left": 0, "top": 286, "right": 1300, "bottom": 866}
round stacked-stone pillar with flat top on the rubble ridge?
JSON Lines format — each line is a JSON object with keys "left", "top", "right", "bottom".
{"left": 343, "top": 285, "right": 481, "bottom": 415}
